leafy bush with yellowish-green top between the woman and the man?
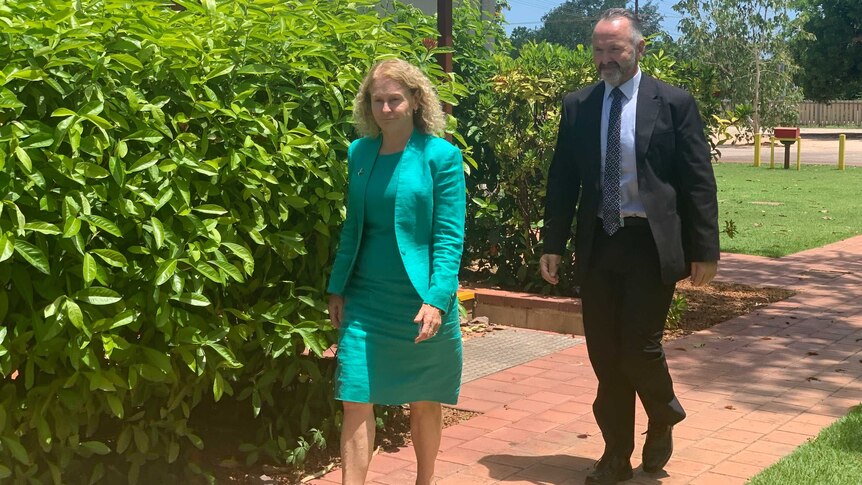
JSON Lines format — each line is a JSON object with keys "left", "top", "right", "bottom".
{"left": 464, "top": 43, "right": 594, "bottom": 291}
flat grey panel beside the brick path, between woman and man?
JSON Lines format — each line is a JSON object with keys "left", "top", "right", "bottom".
{"left": 461, "top": 328, "right": 584, "bottom": 382}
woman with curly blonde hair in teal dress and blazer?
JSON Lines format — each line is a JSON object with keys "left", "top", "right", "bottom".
{"left": 328, "top": 59, "right": 466, "bottom": 485}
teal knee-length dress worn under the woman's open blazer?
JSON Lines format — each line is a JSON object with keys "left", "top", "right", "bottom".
{"left": 335, "top": 153, "right": 462, "bottom": 404}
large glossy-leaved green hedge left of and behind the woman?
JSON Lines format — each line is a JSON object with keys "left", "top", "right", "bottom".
{"left": 0, "top": 0, "right": 455, "bottom": 483}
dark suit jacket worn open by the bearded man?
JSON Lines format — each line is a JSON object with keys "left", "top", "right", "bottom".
{"left": 543, "top": 74, "right": 719, "bottom": 283}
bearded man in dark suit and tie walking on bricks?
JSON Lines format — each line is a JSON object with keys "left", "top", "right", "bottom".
{"left": 541, "top": 9, "right": 719, "bottom": 484}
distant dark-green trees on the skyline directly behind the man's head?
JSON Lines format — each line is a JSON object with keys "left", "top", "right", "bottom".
{"left": 511, "top": 0, "right": 663, "bottom": 49}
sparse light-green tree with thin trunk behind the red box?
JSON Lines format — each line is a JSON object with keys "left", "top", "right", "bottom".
{"left": 673, "top": 0, "right": 804, "bottom": 133}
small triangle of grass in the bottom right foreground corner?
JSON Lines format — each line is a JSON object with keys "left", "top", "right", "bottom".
{"left": 748, "top": 406, "right": 862, "bottom": 485}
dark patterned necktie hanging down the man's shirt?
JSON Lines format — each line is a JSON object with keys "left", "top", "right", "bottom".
{"left": 602, "top": 88, "right": 623, "bottom": 236}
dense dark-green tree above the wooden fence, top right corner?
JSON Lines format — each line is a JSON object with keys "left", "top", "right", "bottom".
{"left": 794, "top": 0, "right": 862, "bottom": 101}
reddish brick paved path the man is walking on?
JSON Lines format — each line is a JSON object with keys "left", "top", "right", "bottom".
{"left": 310, "top": 236, "right": 862, "bottom": 485}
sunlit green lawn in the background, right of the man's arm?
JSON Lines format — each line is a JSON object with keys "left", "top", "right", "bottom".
{"left": 713, "top": 163, "right": 862, "bottom": 257}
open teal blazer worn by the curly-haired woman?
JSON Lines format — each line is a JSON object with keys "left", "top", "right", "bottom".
{"left": 327, "top": 130, "right": 467, "bottom": 312}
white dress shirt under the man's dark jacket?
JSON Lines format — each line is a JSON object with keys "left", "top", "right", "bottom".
{"left": 599, "top": 69, "right": 646, "bottom": 218}
